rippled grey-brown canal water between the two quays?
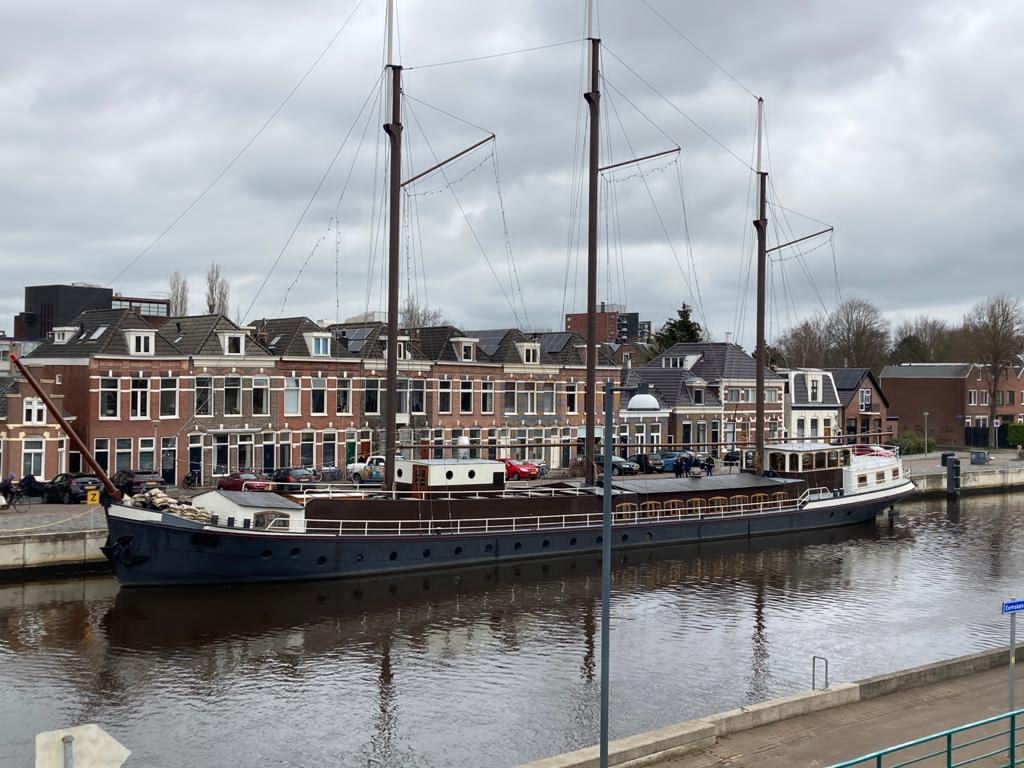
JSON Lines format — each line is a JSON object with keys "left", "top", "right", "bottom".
{"left": 0, "top": 496, "right": 1024, "bottom": 768}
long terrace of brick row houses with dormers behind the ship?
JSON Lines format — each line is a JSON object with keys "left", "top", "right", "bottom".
{"left": 0, "top": 309, "right": 618, "bottom": 482}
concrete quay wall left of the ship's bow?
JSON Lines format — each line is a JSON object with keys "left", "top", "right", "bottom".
{"left": 0, "top": 528, "right": 106, "bottom": 577}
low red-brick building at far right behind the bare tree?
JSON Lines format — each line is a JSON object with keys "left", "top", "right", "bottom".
{"left": 880, "top": 362, "right": 1024, "bottom": 447}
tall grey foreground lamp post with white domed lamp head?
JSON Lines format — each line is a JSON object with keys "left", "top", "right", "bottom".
{"left": 599, "top": 381, "right": 659, "bottom": 768}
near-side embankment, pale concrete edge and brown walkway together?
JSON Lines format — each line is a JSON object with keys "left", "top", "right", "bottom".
{"left": 522, "top": 646, "right": 1010, "bottom": 768}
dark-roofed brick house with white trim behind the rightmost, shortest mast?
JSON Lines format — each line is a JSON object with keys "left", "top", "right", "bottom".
{"left": 626, "top": 342, "right": 785, "bottom": 454}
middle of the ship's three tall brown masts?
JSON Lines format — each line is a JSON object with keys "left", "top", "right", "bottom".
{"left": 584, "top": 30, "right": 598, "bottom": 485}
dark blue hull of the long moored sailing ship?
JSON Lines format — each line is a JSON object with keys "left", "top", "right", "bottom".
{"left": 103, "top": 485, "right": 912, "bottom": 586}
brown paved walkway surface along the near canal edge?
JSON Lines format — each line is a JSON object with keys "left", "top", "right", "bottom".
{"left": 649, "top": 663, "right": 1024, "bottom": 768}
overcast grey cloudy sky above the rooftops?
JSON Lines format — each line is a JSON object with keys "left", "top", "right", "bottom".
{"left": 0, "top": 0, "right": 1024, "bottom": 344}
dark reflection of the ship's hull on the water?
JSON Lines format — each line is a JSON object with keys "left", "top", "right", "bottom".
{"left": 102, "top": 528, "right": 892, "bottom": 651}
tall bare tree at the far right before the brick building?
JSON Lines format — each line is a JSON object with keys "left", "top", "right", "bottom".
{"left": 964, "top": 296, "right": 1024, "bottom": 447}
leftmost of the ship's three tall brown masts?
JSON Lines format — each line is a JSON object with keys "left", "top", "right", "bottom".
{"left": 383, "top": 0, "right": 401, "bottom": 490}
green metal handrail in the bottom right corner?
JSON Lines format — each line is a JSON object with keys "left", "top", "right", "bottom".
{"left": 830, "top": 710, "right": 1024, "bottom": 768}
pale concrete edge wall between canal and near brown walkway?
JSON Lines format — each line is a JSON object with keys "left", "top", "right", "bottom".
{"left": 521, "top": 646, "right": 1010, "bottom": 768}
